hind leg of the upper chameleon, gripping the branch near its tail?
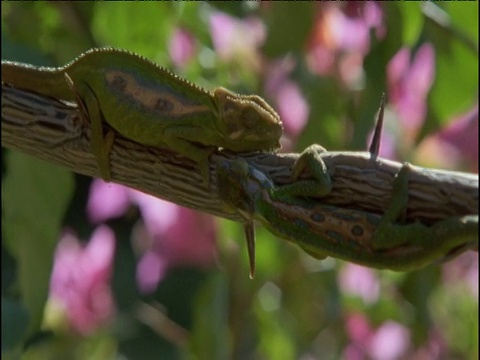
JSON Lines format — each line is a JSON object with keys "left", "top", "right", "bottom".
{"left": 65, "top": 74, "right": 115, "bottom": 181}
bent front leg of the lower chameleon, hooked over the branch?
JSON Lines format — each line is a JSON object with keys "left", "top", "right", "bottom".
{"left": 276, "top": 144, "right": 332, "bottom": 197}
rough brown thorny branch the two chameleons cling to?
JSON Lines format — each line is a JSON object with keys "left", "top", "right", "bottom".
{"left": 2, "top": 84, "right": 478, "bottom": 224}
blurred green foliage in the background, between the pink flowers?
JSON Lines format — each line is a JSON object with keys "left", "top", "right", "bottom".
{"left": 2, "top": 2, "right": 478, "bottom": 359}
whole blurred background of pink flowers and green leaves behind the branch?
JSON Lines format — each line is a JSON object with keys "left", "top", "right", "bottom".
{"left": 2, "top": 2, "right": 478, "bottom": 359}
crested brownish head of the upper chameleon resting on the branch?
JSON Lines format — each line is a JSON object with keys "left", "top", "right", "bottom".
{"left": 213, "top": 87, "right": 283, "bottom": 152}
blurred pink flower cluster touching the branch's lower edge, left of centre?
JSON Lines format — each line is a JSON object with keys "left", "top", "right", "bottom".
{"left": 87, "top": 180, "right": 216, "bottom": 293}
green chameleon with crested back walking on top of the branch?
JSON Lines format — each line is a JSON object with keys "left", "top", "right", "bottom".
{"left": 2, "top": 48, "right": 282, "bottom": 183}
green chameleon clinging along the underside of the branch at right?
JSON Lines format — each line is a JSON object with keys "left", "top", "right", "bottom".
{"left": 217, "top": 153, "right": 478, "bottom": 277}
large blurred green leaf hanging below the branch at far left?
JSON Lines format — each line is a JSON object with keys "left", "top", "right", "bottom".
{"left": 2, "top": 151, "right": 73, "bottom": 331}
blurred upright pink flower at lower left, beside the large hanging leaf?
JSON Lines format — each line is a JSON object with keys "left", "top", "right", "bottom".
{"left": 50, "top": 226, "right": 115, "bottom": 335}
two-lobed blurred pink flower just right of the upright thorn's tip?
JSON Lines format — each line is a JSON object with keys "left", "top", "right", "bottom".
{"left": 387, "top": 44, "right": 435, "bottom": 139}
